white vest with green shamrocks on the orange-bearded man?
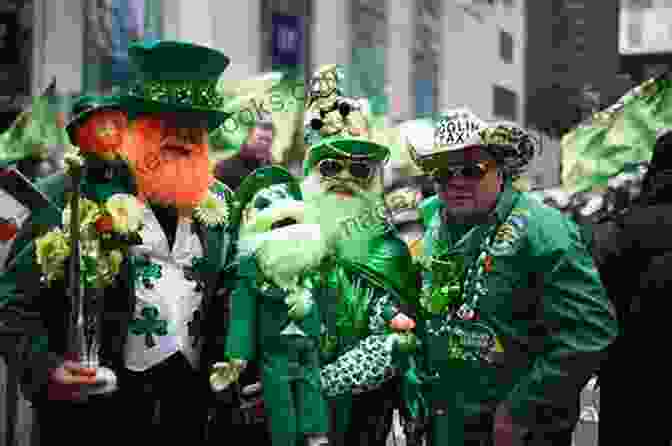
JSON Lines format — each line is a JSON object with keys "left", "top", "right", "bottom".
{"left": 126, "top": 206, "right": 203, "bottom": 371}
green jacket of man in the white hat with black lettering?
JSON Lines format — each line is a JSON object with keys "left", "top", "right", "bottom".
{"left": 418, "top": 184, "right": 618, "bottom": 427}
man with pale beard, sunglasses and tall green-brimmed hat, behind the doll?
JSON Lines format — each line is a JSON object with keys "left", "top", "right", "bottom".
{"left": 303, "top": 65, "right": 418, "bottom": 445}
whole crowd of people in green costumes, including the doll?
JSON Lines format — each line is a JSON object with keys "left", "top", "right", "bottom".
{"left": 0, "top": 41, "right": 672, "bottom": 446}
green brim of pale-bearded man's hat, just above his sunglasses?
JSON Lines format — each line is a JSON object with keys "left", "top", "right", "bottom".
{"left": 304, "top": 136, "right": 390, "bottom": 175}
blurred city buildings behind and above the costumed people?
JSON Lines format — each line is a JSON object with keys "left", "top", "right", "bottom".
{"left": 0, "top": 0, "right": 672, "bottom": 188}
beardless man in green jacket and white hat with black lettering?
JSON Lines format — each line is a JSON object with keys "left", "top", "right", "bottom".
{"left": 412, "top": 109, "right": 618, "bottom": 446}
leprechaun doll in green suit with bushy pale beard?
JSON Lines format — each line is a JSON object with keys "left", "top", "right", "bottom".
{"left": 211, "top": 166, "right": 330, "bottom": 446}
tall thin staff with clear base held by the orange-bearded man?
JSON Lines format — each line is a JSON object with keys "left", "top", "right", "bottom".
{"left": 68, "top": 169, "right": 117, "bottom": 397}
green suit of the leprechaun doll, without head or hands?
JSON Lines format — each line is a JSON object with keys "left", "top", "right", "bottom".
{"left": 226, "top": 256, "right": 328, "bottom": 446}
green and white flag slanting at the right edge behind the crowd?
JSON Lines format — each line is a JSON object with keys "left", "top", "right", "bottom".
{"left": 561, "top": 73, "right": 672, "bottom": 193}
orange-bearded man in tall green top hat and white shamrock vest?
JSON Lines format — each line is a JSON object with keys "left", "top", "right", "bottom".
{"left": 0, "top": 41, "right": 238, "bottom": 444}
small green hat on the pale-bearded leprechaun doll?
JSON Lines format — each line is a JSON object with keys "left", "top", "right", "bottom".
{"left": 231, "top": 166, "right": 303, "bottom": 232}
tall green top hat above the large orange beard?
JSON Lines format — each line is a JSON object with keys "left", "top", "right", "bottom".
{"left": 121, "top": 41, "right": 230, "bottom": 131}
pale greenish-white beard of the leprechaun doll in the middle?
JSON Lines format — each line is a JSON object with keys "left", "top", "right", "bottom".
{"left": 238, "top": 223, "right": 329, "bottom": 288}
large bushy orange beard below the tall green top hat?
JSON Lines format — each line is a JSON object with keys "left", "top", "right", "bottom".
{"left": 121, "top": 116, "right": 214, "bottom": 210}
